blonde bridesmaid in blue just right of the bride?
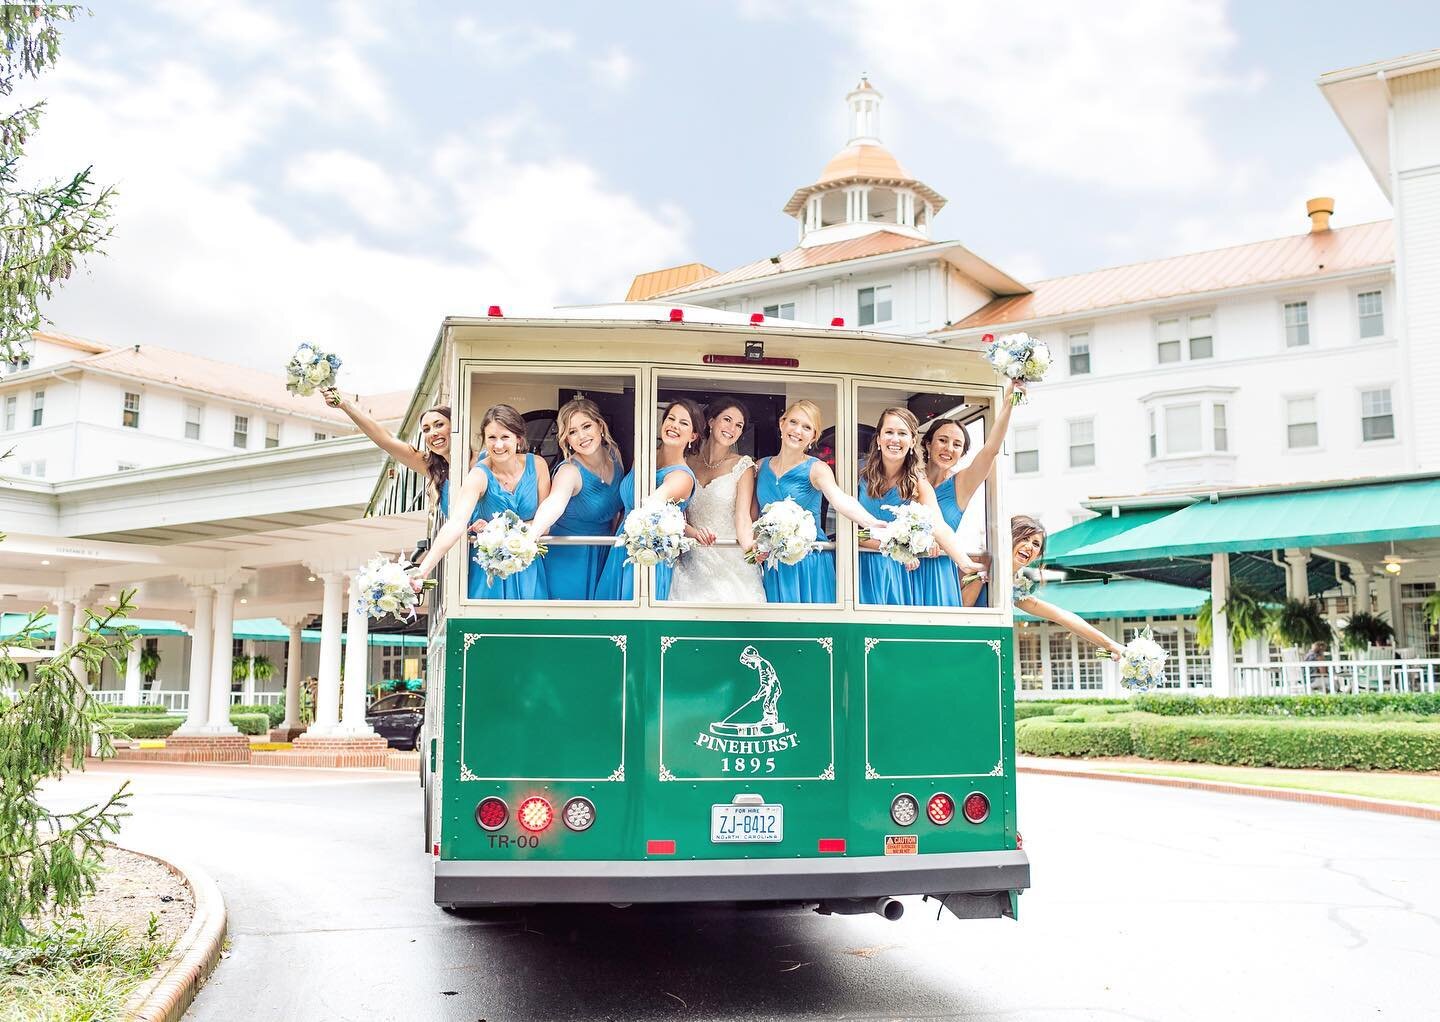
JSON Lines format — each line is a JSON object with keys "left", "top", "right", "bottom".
{"left": 755, "top": 400, "right": 880, "bottom": 603}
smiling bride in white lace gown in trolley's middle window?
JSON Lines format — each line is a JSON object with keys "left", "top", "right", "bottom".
{"left": 670, "top": 397, "right": 765, "bottom": 603}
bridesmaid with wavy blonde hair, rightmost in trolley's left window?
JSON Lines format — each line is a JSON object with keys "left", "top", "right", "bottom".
{"left": 531, "top": 397, "right": 625, "bottom": 600}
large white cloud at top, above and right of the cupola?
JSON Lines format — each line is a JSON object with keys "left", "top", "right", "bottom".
{"left": 812, "top": 0, "right": 1254, "bottom": 193}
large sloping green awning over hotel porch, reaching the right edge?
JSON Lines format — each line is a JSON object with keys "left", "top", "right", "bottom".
{"left": 1065, "top": 478, "right": 1440, "bottom": 567}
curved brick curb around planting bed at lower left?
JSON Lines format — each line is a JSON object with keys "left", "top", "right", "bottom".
{"left": 121, "top": 848, "right": 226, "bottom": 1022}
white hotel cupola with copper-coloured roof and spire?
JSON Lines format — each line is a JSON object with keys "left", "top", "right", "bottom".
{"left": 785, "top": 76, "right": 945, "bottom": 248}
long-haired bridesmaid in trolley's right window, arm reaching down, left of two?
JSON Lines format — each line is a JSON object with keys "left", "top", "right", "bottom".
{"left": 860, "top": 407, "right": 981, "bottom": 606}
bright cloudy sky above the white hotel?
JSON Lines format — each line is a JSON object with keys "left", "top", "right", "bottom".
{"left": 19, "top": 0, "right": 1440, "bottom": 390}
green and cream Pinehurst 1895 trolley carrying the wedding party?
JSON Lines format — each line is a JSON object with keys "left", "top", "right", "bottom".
{"left": 377, "top": 305, "right": 1030, "bottom": 918}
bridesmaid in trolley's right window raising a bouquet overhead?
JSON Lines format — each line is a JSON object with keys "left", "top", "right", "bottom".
{"left": 910, "top": 380, "right": 1015, "bottom": 607}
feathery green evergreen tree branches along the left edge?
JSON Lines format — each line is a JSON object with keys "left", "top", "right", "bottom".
{"left": 0, "top": 4, "right": 134, "bottom": 946}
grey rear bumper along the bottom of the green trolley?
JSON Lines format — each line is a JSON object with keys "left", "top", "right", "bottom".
{"left": 435, "top": 849, "right": 1030, "bottom": 905}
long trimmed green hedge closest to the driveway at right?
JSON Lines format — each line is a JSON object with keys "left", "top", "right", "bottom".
{"left": 1128, "top": 717, "right": 1440, "bottom": 770}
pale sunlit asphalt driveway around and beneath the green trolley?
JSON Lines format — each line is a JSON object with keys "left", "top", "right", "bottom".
{"left": 42, "top": 764, "right": 1440, "bottom": 1022}
